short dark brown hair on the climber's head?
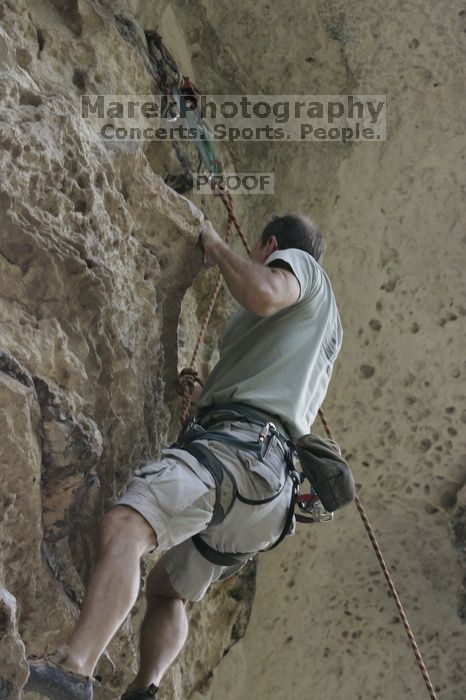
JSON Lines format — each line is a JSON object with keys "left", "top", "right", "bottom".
{"left": 261, "top": 212, "right": 326, "bottom": 263}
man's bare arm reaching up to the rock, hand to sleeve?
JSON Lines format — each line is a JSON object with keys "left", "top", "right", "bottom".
{"left": 198, "top": 222, "right": 300, "bottom": 316}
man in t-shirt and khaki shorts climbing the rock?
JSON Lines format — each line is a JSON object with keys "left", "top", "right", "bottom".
{"left": 28, "top": 214, "right": 342, "bottom": 700}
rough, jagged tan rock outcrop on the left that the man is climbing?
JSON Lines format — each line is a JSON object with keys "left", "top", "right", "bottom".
{"left": 0, "top": 1, "right": 254, "bottom": 698}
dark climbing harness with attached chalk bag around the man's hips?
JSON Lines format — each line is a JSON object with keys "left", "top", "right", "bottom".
{"left": 170, "top": 402, "right": 356, "bottom": 565}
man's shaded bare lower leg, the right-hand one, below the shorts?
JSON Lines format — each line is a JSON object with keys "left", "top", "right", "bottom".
{"left": 124, "top": 557, "right": 188, "bottom": 690}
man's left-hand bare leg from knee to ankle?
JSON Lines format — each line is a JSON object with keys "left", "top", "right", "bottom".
{"left": 61, "top": 505, "right": 157, "bottom": 676}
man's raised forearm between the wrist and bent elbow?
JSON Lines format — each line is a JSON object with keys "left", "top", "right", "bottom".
{"left": 209, "top": 239, "right": 271, "bottom": 312}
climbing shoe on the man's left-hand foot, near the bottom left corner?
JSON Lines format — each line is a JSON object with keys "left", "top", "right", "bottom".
{"left": 24, "top": 645, "right": 98, "bottom": 700}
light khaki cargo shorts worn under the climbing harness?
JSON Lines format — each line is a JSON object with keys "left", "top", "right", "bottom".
{"left": 117, "top": 421, "right": 292, "bottom": 601}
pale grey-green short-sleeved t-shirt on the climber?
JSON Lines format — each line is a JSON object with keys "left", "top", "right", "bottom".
{"left": 198, "top": 248, "right": 343, "bottom": 440}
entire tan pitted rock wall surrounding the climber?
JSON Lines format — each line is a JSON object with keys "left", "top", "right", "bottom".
{"left": 0, "top": 0, "right": 466, "bottom": 700}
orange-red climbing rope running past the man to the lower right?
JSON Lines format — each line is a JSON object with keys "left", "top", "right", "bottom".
{"left": 179, "top": 175, "right": 437, "bottom": 700}
